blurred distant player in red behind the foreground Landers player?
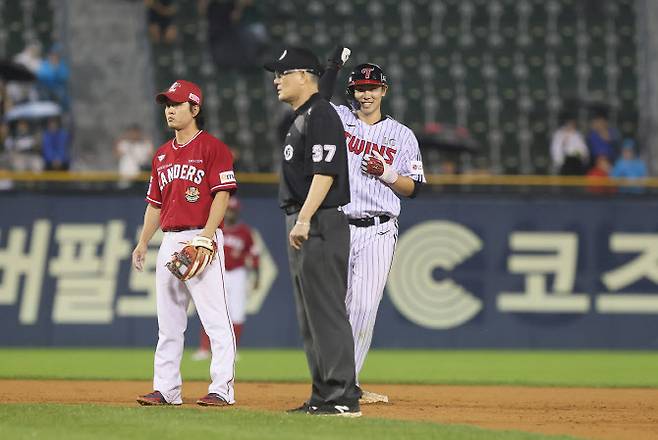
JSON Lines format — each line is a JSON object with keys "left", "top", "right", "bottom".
{"left": 193, "top": 196, "right": 258, "bottom": 360}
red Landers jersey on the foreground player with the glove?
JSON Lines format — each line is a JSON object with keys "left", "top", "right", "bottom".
{"left": 146, "top": 130, "right": 237, "bottom": 230}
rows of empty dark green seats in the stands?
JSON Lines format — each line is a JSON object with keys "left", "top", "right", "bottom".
{"left": 0, "top": 0, "right": 638, "bottom": 174}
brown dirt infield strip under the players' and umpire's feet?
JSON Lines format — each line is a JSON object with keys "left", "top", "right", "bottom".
{"left": 0, "top": 380, "right": 658, "bottom": 440}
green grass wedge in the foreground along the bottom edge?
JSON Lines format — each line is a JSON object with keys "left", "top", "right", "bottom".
{"left": 0, "top": 405, "right": 573, "bottom": 440}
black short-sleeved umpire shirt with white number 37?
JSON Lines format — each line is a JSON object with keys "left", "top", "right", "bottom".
{"left": 279, "top": 93, "right": 350, "bottom": 210}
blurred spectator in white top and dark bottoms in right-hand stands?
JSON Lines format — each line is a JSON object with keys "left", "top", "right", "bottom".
{"left": 551, "top": 112, "right": 589, "bottom": 176}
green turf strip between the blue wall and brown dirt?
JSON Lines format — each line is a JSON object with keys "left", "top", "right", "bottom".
{"left": 0, "top": 348, "right": 658, "bottom": 387}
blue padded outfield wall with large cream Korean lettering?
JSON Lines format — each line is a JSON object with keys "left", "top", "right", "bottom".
{"left": 0, "top": 193, "right": 658, "bottom": 349}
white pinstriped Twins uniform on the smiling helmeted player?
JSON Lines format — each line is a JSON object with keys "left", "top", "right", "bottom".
{"left": 334, "top": 105, "right": 425, "bottom": 382}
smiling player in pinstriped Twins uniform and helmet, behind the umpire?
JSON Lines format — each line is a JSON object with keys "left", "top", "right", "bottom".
{"left": 320, "top": 53, "right": 425, "bottom": 403}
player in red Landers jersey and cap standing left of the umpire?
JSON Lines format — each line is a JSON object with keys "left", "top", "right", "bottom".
{"left": 133, "top": 80, "right": 237, "bottom": 406}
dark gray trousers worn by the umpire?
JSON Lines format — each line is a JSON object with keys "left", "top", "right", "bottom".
{"left": 286, "top": 208, "right": 361, "bottom": 406}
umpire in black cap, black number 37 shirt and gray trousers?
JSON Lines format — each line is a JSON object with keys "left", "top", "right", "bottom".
{"left": 265, "top": 47, "right": 361, "bottom": 417}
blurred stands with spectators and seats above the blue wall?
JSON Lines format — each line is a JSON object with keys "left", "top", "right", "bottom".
{"left": 0, "top": 0, "right": 658, "bottom": 187}
